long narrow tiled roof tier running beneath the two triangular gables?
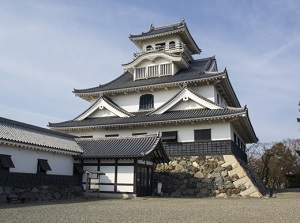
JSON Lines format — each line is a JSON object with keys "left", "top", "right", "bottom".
{"left": 49, "top": 108, "right": 246, "bottom": 128}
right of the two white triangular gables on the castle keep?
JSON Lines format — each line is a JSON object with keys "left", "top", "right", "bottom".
{"left": 148, "top": 87, "right": 223, "bottom": 115}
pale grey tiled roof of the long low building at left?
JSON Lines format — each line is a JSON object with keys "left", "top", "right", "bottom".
{"left": 0, "top": 117, "right": 82, "bottom": 153}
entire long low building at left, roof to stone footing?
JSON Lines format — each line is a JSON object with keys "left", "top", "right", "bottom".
{"left": 0, "top": 117, "right": 83, "bottom": 202}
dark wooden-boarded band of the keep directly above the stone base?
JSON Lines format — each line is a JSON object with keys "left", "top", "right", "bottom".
{"left": 163, "top": 140, "right": 247, "bottom": 163}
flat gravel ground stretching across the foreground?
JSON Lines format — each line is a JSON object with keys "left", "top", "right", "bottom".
{"left": 0, "top": 197, "right": 300, "bottom": 223}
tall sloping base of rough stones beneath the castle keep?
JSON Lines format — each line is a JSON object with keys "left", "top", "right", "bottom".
{"left": 154, "top": 155, "right": 263, "bottom": 198}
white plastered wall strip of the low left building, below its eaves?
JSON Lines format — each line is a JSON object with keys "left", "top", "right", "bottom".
{"left": 0, "top": 144, "right": 74, "bottom": 176}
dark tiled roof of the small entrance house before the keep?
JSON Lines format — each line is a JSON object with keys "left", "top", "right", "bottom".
{"left": 76, "top": 135, "right": 169, "bottom": 162}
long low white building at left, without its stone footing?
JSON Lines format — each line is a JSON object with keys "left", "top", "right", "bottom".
{"left": 0, "top": 118, "right": 83, "bottom": 185}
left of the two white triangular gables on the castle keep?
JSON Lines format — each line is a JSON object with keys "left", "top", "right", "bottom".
{"left": 74, "top": 95, "right": 133, "bottom": 121}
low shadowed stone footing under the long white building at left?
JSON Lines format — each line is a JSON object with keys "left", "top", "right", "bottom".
{"left": 0, "top": 185, "right": 83, "bottom": 203}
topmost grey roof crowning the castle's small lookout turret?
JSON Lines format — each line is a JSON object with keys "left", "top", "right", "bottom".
{"left": 129, "top": 19, "right": 201, "bottom": 54}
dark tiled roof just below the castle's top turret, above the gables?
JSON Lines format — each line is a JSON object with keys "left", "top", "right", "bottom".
{"left": 73, "top": 57, "right": 216, "bottom": 94}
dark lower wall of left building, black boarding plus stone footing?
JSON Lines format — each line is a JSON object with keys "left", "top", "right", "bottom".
{"left": 0, "top": 172, "right": 83, "bottom": 203}
